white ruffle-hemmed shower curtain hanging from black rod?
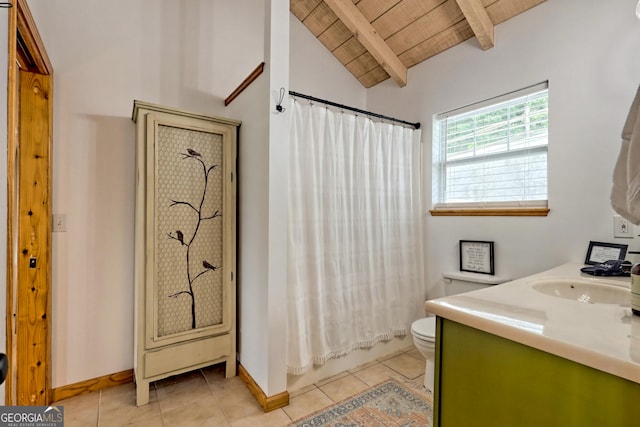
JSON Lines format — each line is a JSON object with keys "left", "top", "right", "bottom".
{"left": 287, "top": 99, "right": 424, "bottom": 375}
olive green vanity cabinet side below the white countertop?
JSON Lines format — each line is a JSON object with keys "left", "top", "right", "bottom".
{"left": 433, "top": 317, "right": 640, "bottom": 427}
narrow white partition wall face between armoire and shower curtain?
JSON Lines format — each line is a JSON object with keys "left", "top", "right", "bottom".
{"left": 224, "top": 73, "right": 269, "bottom": 394}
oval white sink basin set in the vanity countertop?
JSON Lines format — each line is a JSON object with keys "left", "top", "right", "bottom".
{"left": 532, "top": 279, "right": 631, "bottom": 306}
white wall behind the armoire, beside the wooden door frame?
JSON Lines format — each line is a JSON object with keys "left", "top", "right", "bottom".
{"left": 28, "top": 0, "right": 264, "bottom": 387}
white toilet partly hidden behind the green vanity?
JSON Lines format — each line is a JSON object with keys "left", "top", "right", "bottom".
{"left": 411, "top": 273, "right": 509, "bottom": 391}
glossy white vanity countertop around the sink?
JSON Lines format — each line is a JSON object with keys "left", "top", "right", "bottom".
{"left": 425, "top": 263, "right": 640, "bottom": 383}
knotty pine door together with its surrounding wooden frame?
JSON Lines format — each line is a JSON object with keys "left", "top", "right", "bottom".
{"left": 5, "top": 0, "right": 53, "bottom": 405}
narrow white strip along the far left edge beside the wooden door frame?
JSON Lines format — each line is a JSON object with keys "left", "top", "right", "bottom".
{"left": 0, "top": 9, "right": 9, "bottom": 405}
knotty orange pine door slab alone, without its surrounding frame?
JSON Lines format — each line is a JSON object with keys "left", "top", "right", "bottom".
{"left": 13, "top": 71, "right": 51, "bottom": 405}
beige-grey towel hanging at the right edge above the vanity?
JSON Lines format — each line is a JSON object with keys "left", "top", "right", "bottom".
{"left": 611, "top": 87, "right": 640, "bottom": 225}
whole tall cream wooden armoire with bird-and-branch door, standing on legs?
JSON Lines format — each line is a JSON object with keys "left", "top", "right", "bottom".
{"left": 133, "top": 101, "right": 240, "bottom": 406}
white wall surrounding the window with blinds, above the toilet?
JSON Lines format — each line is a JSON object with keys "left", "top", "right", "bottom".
{"left": 367, "top": 0, "right": 640, "bottom": 298}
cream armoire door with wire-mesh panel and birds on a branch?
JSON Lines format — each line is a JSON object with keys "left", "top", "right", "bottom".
{"left": 146, "top": 113, "right": 233, "bottom": 348}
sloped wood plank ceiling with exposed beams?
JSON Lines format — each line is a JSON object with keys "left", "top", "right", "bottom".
{"left": 290, "top": 0, "right": 545, "bottom": 87}
